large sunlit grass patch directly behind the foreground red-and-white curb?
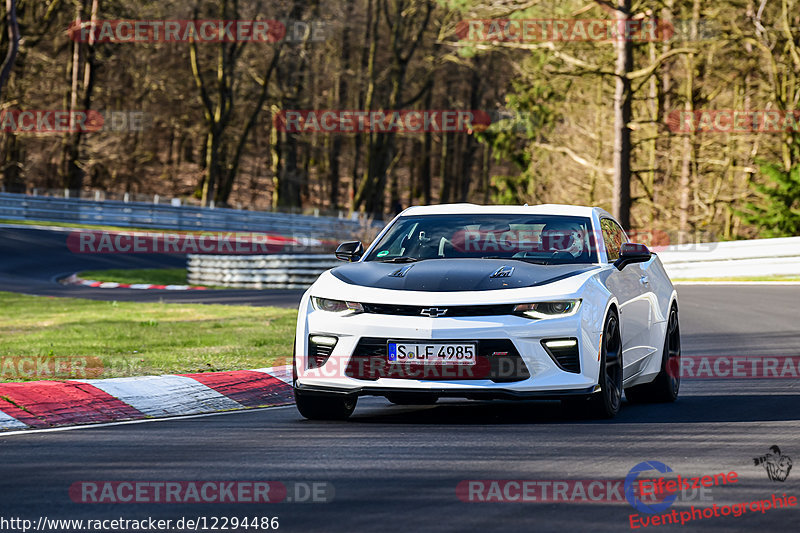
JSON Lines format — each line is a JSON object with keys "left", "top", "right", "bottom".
{"left": 0, "top": 292, "right": 297, "bottom": 381}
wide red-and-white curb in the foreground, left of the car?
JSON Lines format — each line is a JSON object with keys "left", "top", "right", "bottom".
{"left": 0, "top": 365, "right": 294, "bottom": 431}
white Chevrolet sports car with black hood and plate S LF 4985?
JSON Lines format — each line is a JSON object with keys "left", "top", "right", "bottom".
{"left": 294, "top": 204, "right": 680, "bottom": 419}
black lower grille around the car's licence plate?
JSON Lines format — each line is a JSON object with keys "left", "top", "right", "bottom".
{"left": 345, "top": 337, "right": 530, "bottom": 383}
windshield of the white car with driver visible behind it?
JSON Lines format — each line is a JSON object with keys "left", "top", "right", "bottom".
{"left": 364, "top": 215, "right": 597, "bottom": 264}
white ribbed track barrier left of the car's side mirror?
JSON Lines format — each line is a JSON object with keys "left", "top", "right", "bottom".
{"left": 187, "top": 254, "right": 342, "bottom": 289}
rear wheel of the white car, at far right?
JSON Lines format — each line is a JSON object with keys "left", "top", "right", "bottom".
{"left": 625, "top": 304, "right": 681, "bottom": 403}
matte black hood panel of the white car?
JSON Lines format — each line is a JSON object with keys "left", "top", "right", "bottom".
{"left": 331, "top": 259, "right": 598, "bottom": 292}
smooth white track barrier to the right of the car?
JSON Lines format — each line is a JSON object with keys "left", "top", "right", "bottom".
{"left": 658, "top": 237, "right": 800, "bottom": 279}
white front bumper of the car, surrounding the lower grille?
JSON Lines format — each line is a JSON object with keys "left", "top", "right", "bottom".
{"left": 295, "top": 297, "right": 600, "bottom": 399}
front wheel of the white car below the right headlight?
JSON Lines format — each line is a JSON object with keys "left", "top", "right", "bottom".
{"left": 561, "top": 311, "right": 622, "bottom": 418}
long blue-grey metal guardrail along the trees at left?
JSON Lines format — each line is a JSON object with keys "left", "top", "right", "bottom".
{"left": 0, "top": 193, "right": 362, "bottom": 239}
